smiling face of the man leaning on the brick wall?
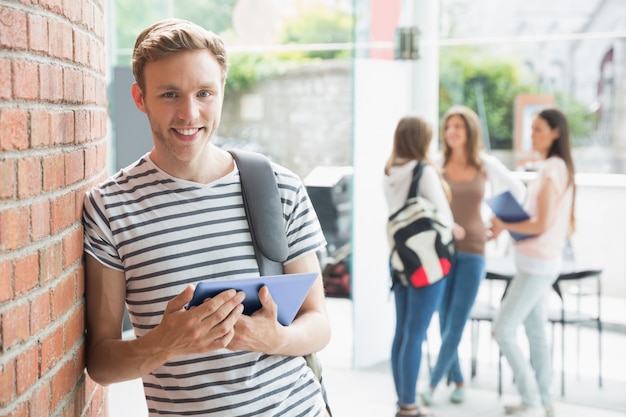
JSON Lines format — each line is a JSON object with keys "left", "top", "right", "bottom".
{"left": 132, "top": 51, "right": 224, "bottom": 169}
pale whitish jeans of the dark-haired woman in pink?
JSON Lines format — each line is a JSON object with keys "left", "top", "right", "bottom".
{"left": 493, "top": 271, "right": 558, "bottom": 407}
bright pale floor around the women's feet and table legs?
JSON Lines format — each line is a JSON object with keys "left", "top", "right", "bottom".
{"left": 109, "top": 299, "right": 626, "bottom": 417}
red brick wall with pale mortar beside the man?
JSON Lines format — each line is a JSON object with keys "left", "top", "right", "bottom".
{"left": 0, "top": 0, "right": 107, "bottom": 417}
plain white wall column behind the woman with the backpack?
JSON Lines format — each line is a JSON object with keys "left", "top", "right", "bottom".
{"left": 352, "top": 0, "right": 439, "bottom": 368}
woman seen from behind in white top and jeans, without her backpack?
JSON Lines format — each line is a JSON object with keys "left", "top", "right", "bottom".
{"left": 383, "top": 116, "right": 453, "bottom": 416}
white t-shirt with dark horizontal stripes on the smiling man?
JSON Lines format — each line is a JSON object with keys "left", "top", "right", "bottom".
{"left": 84, "top": 155, "right": 325, "bottom": 417}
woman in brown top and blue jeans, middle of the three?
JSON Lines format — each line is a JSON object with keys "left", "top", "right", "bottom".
{"left": 420, "top": 106, "right": 525, "bottom": 405}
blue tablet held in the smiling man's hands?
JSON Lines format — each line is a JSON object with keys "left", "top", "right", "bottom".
{"left": 187, "top": 272, "right": 318, "bottom": 326}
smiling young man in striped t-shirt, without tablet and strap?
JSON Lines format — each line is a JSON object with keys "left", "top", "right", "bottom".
{"left": 84, "top": 19, "right": 330, "bottom": 416}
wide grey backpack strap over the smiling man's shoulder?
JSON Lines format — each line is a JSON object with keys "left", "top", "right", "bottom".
{"left": 229, "top": 150, "right": 288, "bottom": 275}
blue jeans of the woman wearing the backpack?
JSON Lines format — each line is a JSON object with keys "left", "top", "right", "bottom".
{"left": 391, "top": 278, "right": 447, "bottom": 404}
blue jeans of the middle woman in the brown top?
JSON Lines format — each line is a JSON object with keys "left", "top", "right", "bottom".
{"left": 430, "top": 252, "right": 485, "bottom": 388}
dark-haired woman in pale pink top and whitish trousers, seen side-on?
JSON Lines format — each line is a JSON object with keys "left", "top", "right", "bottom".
{"left": 493, "top": 109, "right": 575, "bottom": 417}
